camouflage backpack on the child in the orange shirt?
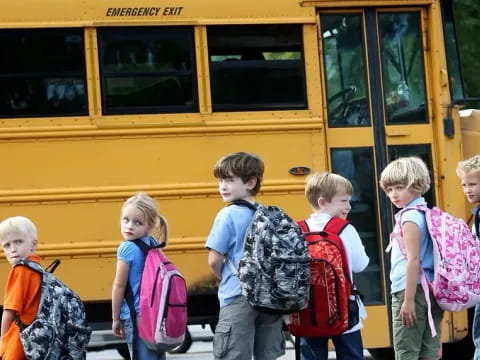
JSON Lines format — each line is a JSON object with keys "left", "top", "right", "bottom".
{"left": 15, "top": 259, "right": 92, "bottom": 360}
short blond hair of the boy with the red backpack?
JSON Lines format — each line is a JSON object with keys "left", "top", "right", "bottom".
{"left": 305, "top": 172, "right": 353, "bottom": 210}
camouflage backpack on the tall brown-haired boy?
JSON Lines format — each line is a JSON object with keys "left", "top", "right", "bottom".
{"left": 228, "top": 201, "right": 310, "bottom": 314}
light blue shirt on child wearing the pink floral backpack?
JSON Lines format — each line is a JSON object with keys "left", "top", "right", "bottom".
{"left": 390, "top": 197, "right": 434, "bottom": 294}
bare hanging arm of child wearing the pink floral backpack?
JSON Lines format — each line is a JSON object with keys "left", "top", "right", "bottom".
{"left": 400, "top": 221, "right": 420, "bottom": 327}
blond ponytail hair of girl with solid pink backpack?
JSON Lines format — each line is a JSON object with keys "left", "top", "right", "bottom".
{"left": 120, "top": 192, "right": 168, "bottom": 246}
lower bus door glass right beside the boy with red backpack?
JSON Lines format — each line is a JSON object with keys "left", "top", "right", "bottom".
{"left": 331, "top": 147, "right": 383, "bottom": 304}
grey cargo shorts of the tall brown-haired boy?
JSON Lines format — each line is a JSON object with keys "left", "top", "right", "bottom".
{"left": 213, "top": 295, "right": 285, "bottom": 360}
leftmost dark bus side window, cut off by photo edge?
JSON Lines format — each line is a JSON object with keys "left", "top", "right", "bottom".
{"left": 0, "top": 29, "right": 87, "bottom": 118}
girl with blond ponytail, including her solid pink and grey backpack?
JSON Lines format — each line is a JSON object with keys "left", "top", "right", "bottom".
{"left": 112, "top": 193, "right": 187, "bottom": 360}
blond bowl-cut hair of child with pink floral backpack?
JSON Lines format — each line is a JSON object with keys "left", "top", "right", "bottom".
{"left": 380, "top": 156, "right": 430, "bottom": 194}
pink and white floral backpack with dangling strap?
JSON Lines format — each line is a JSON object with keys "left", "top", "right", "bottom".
{"left": 390, "top": 205, "right": 480, "bottom": 336}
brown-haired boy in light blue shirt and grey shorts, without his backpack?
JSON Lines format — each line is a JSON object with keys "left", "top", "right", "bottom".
{"left": 205, "top": 152, "right": 285, "bottom": 360}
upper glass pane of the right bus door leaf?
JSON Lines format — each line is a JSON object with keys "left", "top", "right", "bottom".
{"left": 378, "top": 12, "right": 428, "bottom": 124}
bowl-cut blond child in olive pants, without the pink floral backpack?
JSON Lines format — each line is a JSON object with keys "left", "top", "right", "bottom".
{"left": 380, "top": 157, "right": 443, "bottom": 360}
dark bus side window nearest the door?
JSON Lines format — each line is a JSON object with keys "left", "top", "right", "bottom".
{"left": 207, "top": 25, "right": 307, "bottom": 111}
